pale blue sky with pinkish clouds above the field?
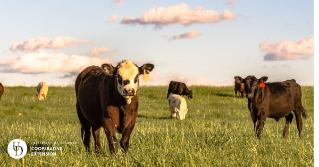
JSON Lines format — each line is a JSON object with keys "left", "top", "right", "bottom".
{"left": 0, "top": 0, "right": 314, "bottom": 86}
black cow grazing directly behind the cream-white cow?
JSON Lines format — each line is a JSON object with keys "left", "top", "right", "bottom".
{"left": 167, "top": 81, "right": 193, "bottom": 99}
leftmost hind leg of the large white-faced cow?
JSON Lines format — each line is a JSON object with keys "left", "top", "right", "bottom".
{"left": 76, "top": 102, "right": 92, "bottom": 152}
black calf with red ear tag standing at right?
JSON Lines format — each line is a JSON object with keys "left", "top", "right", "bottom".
{"left": 239, "top": 76, "right": 307, "bottom": 139}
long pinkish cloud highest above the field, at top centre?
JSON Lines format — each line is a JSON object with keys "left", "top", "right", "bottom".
{"left": 121, "top": 3, "right": 236, "bottom": 28}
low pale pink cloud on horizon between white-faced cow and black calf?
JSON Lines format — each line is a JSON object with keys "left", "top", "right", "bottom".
{"left": 140, "top": 71, "right": 233, "bottom": 85}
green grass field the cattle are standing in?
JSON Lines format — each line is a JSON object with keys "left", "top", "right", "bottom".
{"left": 0, "top": 86, "right": 314, "bottom": 166}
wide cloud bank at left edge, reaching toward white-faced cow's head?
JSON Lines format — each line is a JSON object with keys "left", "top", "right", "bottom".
{"left": 0, "top": 51, "right": 111, "bottom": 74}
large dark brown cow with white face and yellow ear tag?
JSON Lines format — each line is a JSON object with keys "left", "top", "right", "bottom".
{"left": 75, "top": 60, "right": 154, "bottom": 155}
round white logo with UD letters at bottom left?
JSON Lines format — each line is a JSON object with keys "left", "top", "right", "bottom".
{"left": 8, "top": 139, "right": 28, "bottom": 159}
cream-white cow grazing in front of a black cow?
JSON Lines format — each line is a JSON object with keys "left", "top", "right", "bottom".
{"left": 168, "top": 94, "right": 188, "bottom": 120}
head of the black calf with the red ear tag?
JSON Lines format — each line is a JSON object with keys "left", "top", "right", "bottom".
{"left": 235, "top": 75, "right": 268, "bottom": 99}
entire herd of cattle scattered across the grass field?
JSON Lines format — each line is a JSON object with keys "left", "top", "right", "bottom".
{"left": 0, "top": 60, "right": 307, "bottom": 154}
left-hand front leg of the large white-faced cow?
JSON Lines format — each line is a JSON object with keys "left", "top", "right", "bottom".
{"left": 103, "top": 118, "right": 119, "bottom": 154}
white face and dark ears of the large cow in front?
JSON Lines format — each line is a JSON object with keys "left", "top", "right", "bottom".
{"left": 103, "top": 60, "right": 154, "bottom": 104}
